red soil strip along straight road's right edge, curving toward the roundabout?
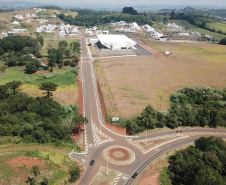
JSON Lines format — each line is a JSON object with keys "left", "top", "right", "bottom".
{"left": 97, "top": 81, "right": 130, "bottom": 135}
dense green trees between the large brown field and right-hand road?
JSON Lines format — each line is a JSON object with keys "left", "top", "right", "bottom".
{"left": 123, "top": 87, "right": 226, "bottom": 134}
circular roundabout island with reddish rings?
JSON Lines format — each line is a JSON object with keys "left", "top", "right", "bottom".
{"left": 102, "top": 146, "right": 135, "bottom": 165}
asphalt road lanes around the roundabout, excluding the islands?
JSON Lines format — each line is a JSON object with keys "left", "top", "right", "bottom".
{"left": 70, "top": 29, "right": 226, "bottom": 185}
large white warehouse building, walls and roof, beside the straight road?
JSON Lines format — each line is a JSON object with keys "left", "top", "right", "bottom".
{"left": 97, "top": 34, "right": 137, "bottom": 50}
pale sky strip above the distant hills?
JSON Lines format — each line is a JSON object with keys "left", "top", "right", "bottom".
{"left": 0, "top": 0, "right": 226, "bottom": 6}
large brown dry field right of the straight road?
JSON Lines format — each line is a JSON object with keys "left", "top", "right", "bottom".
{"left": 95, "top": 40, "right": 226, "bottom": 118}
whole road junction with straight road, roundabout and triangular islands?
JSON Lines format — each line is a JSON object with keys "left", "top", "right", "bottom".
{"left": 69, "top": 31, "right": 226, "bottom": 185}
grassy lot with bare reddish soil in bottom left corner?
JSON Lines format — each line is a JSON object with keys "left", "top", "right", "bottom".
{"left": 0, "top": 149, "right": 81, "bottom": 184}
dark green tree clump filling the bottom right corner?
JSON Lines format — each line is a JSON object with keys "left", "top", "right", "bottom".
{"left": 166, "top": 136, "right": 226, "bottom": 185}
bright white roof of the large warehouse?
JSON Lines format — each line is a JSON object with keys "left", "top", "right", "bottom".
{"left": 97, "top": 34, "right": 136, "bottom": 45}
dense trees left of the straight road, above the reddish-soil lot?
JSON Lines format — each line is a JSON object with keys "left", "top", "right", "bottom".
{"left": 0, "top": 81, "right": 87, "bottom": 149}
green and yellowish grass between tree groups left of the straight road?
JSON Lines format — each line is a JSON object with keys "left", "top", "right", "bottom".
{"left": 0, "top": 62, "right": 78, "bottom": 105}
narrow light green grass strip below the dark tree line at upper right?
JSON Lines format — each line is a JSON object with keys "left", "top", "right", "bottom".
{"left": 173, "top": 20, "right": 226, "bottom": 41}
